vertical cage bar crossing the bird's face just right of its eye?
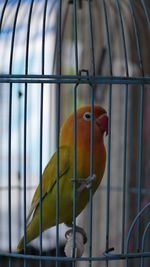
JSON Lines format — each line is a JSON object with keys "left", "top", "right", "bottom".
{"left": 88, "top": 0, "right": 95, "bottom": 267}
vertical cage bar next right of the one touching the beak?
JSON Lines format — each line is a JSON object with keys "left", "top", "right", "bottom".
{"left": 116, "top": 0, "right": 129, "bottom": 253}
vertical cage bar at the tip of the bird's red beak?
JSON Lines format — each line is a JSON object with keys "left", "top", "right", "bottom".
{"left": 103, "top": 3, "right": 112, "bottom": 266}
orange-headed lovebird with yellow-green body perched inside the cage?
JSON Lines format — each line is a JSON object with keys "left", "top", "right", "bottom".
{"left": 17, "top": 105, "right": 108, "bottom": 252}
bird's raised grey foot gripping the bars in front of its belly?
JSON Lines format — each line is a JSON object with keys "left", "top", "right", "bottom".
{"left": 71, "top": 174, "right": 96, "bottom": 193}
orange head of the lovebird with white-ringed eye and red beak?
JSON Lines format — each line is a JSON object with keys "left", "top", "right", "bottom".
{"left": 60, "top": 105, "right": 108, "bottom": 149}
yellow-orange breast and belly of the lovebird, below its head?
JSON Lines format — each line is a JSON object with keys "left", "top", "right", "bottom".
{"left": 56, "top": 145, "right": 106, "bottom": 224}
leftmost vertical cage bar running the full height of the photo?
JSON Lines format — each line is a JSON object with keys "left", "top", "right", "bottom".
{"left": 8, "top": 0, "right": 21, "bottom": 267}
